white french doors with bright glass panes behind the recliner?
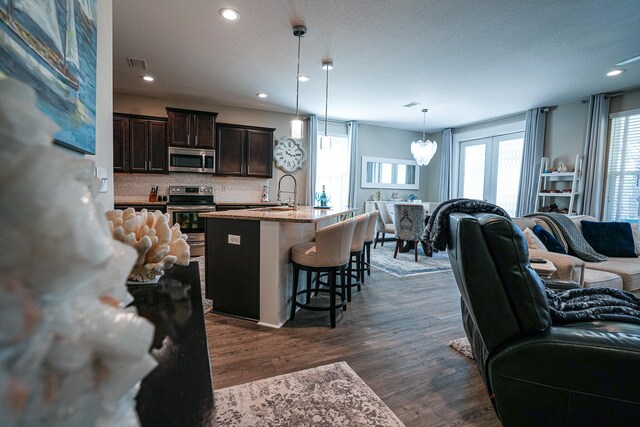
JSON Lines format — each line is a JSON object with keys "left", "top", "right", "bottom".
{"left": 458, "top": 132, "right": 524, "bottom": 215}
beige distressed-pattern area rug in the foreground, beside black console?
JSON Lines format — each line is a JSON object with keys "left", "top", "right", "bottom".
{"left": 215, "top": 362, "right": 404, "bottom": 427}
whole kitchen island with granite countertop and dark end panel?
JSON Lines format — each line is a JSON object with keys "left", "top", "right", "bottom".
{"left": 200, "top": 206, "right": 355, "bottom": 328}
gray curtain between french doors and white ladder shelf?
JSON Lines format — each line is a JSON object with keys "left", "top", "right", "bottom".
{"left": 516, "top": 108, "right": 547, "bottom": 216}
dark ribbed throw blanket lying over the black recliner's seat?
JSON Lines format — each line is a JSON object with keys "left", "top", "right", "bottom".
{"left": 545, "top": 287, "right": 640, "bottom": 324}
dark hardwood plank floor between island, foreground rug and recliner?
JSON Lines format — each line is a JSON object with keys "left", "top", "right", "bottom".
{"left": 205, "top": 269, "right": 500, "bottom": 426}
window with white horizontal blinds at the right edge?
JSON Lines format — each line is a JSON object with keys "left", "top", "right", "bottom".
{"left": 604, "top": 109, "right": 640, "bottom": 222}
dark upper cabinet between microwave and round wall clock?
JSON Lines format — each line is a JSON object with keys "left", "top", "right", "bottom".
{"left": 216, "top": 123, "right": 275, "bottom": 178}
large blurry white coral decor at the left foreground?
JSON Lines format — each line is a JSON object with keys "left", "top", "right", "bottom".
{"left": 0, "top": 79, "right": 157, "bottom": 427}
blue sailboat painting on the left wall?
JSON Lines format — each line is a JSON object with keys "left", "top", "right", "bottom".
{"left": 0, "top": 0, "right": 98, "bottom": 154}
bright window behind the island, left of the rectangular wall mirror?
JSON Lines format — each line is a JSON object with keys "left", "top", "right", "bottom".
{"left": 315, "top": 135, "right": 350, "bottom": 206}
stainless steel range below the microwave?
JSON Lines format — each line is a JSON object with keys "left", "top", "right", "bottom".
{"left": 167, "top": 185, "right": 216, "bottom": 257}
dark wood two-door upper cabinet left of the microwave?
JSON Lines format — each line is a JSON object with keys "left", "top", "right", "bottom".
{"left": 113, "top": 114, "right": 167, "bottom": 173}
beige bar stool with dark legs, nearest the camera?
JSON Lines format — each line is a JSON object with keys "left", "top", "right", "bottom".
{"left": 289, "top": 218, "right": 356, "bottom": 328}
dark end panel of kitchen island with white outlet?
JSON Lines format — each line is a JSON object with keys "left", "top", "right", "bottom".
{"left": 205, "top": 218, "right": 260, "bottom": 320}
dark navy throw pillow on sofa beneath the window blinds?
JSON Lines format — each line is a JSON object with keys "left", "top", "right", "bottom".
{"left": 580, "top": 221, "right": 638, "bottom": 258}
